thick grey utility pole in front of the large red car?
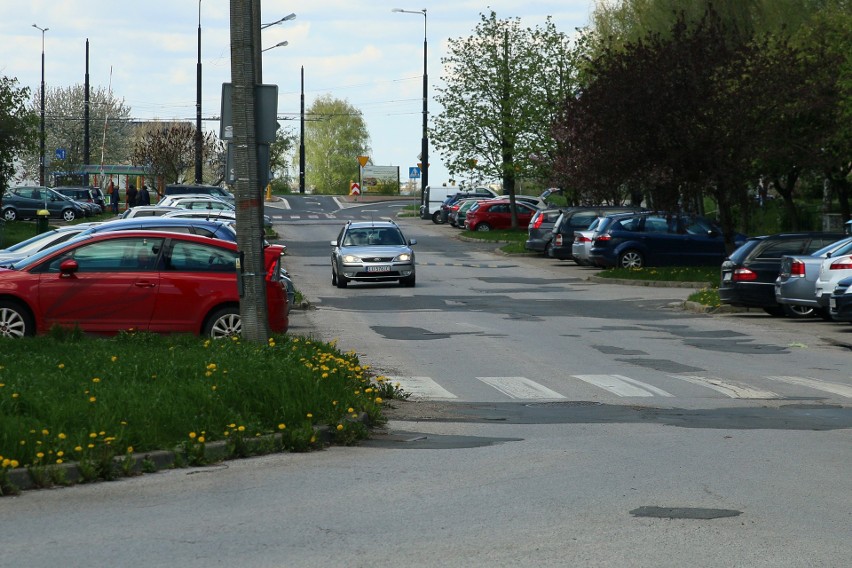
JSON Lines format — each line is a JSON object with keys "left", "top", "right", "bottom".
{"left": 230, "top": 0, "right": 269, "bottom": 343}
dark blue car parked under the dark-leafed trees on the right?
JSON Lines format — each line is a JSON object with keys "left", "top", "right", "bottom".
{"left": 589, "top": 212, "right": 746, "bottom": 268}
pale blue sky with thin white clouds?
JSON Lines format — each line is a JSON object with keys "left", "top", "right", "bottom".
{"left": 0, "top": 0, "right": 595, "bottom": 189}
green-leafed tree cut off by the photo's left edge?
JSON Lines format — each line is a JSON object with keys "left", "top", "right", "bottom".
{"left": 0, "top": 76, "right": 39, "bottom": 191}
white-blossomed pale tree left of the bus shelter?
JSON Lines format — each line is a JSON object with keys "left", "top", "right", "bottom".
{"left": 22, "top": 85, "right": 133, "bottom": 182}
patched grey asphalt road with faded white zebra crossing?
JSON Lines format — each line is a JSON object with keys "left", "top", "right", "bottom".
{"left": 0, "top": 198, "right": 852, "bottom": 568}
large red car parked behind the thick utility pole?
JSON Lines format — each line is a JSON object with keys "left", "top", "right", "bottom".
{"left": 0, "top": 231, "right": 289, "bottom": 338}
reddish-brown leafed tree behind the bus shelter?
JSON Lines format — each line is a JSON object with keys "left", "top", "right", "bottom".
{"left": 131, "top": 122, "right": 224, "bottom": 184}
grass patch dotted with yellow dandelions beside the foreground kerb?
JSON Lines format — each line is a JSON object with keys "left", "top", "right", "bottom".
{"left": 0, "top": 329, "right": 400, "bottom": 495}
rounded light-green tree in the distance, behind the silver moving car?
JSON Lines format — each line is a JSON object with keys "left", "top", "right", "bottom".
{"left": 302, "top": 95, "right": 370, "bottom": 194}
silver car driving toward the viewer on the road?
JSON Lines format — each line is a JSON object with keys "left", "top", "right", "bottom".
{"left": 331, "top": 221, "right": 417, "bottom": 288}
